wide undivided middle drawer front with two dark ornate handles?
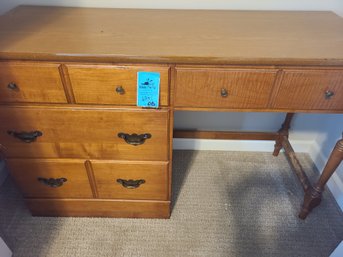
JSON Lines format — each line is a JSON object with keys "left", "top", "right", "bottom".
{"left": 0, "top": 107, "right": 169, "bottom": 160}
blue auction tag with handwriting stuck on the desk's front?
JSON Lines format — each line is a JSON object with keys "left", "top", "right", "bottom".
{"left": 137, "top": 71, "right": 160, "bottom": 108}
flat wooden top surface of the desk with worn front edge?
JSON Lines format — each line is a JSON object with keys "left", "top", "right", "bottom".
{"left": 0, "top": 6, "right": 343, "bottom": 65}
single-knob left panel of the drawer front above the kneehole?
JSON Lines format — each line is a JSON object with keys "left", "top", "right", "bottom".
{"left": 175, "top": 68, "right": 276, "bottom": 108}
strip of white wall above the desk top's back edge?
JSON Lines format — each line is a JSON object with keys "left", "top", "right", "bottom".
{"left": 0, "top": 0, "right": 343, "bottom": 15}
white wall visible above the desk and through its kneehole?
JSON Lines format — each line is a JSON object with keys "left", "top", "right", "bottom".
{"left": 0, "top": 0, "right": 343, "bottom": 206}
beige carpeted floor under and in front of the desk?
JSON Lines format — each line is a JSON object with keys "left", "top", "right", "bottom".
{"left": 0, "top": 151, "right": 343, "bottom": 257}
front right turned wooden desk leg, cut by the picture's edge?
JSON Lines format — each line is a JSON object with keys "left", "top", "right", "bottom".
{"left": 299, "top": 135, "right": 343, "bottom": 219}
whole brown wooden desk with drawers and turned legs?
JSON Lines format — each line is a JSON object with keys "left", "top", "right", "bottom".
{"left": 0, "top": 6, "right": 343, "bottom": 218}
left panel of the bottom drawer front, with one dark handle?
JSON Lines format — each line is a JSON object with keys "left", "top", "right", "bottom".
{"left": 7, "top": 159, "right": 93, "bottom": 198}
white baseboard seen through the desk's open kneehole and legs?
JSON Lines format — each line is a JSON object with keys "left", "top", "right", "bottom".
{"left": 173, "top": 138, "right": 343, "bottom": 211}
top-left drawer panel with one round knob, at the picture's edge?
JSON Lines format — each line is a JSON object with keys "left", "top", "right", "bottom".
{"left": 0, "top": 62, "right": 67, "bottom": 103}
